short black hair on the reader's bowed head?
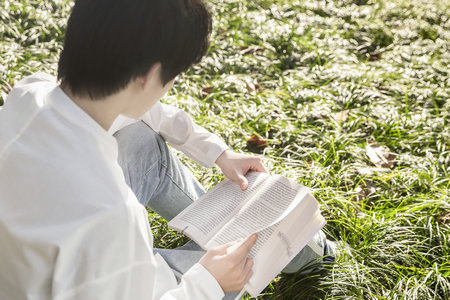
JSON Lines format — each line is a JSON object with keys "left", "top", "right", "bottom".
{"left": 58, "top": 0, "right": 211, "bottom": 99}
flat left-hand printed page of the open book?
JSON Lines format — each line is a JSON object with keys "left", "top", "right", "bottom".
{"left": 169, "top": 172, "right": 270, "bottom": 247}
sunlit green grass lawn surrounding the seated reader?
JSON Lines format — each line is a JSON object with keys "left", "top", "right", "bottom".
{"left": 0, "top": 0, "right": 450, "bottom": 300}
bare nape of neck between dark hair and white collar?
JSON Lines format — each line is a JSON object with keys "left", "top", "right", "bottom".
{"left": 61, "top": 84, "right": 126, "bottom": 131}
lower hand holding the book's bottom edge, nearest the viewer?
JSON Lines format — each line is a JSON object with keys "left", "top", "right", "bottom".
{"left": 199, "top": 234, "right": 258, "bottom": 293}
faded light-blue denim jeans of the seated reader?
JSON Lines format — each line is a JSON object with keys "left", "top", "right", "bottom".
{"left": 115, "top": 122, "right": 334, "bottom": 299}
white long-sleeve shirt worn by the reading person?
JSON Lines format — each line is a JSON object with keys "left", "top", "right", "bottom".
{"left": 0, "top": 74, "right": 226, "bottom": 300}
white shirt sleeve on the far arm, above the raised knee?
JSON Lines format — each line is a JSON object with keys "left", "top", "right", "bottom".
{"left": 109, "top": 102, "right": 229, "bottom": 168}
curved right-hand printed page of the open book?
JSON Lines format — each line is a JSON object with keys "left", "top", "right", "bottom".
{"left": 206, "top": 176, "right": 308, "bottom": 249}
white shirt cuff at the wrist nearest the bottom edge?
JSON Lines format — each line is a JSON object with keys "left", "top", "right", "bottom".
{"left": 183, "top": 263, "right": 225, "bottom": 300}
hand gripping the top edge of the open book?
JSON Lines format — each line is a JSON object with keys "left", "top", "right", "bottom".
{"left": 216, "top": 150, "right": 268, "bottom": 190}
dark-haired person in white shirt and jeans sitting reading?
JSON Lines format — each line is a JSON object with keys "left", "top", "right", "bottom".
{"left": 0, "top": 0, "right": 331, "bottom": 300}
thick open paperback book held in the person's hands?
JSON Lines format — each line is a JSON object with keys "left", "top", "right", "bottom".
{"left": 169, "top": 172, "right": 325, "bottom": 297}
